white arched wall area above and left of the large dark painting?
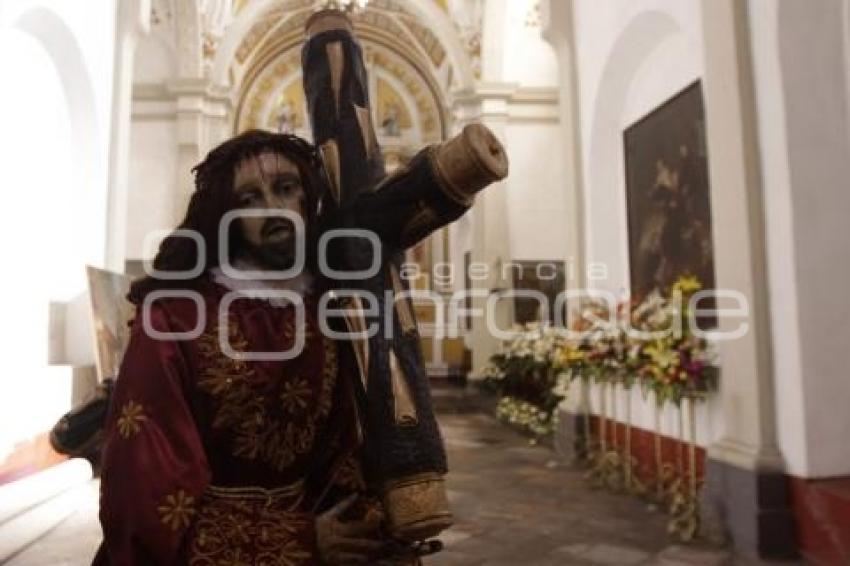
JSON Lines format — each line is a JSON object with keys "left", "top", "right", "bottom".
{"left": 575, "top": 0, "right": 702, "bottom": 298}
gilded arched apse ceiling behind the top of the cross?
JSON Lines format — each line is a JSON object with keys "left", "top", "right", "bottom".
{"left": 231, "top": 0, "right": 446, "bottom": 143}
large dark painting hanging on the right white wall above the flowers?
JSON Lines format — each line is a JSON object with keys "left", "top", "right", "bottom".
{"left": 625, "top": 82, "right": 714, "bottom": 320}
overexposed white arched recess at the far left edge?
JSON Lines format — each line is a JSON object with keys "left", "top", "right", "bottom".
{"left": 0, "top": 6, "right": 100, "bottom": 434}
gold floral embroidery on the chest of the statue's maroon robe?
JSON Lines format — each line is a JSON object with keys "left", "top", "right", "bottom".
{"left": 198, "top": 317, "right": 337, "bottom": 471}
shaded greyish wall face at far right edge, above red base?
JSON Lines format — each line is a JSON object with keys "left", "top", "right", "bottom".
{"left": 780, "top": 2, "right": 850, "bottom": 477}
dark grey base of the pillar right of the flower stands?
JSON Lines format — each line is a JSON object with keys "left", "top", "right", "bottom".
{"left": 702, "top": 458, "right": 797, "bottom": 560}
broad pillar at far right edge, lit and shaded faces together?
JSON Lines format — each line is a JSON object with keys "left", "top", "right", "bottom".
{"left": 749, "top": 0, "right": 850, "bottom": 478}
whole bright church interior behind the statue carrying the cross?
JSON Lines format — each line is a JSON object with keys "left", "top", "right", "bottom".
{"left": 0, "top": 0, "right": 850, "bottom": 566}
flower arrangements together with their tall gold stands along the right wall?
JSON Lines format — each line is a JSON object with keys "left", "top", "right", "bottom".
{"left": 484, "top": 276, "right": 719, "bottom": 541}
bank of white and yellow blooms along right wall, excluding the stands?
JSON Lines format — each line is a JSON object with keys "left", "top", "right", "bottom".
{"left": 484, "top": 276, "right": 719, "bottom": 435}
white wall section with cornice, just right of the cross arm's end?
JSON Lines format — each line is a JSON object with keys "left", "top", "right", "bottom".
{"left": 460, "top": 0, "right": 568, "bottom": 268}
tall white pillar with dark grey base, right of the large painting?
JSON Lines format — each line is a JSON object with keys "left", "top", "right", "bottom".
{"left": 701, "top": 0, "right": 796, "bottom": 558}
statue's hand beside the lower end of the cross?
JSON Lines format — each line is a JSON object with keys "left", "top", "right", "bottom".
{"left": 316, "top": 494, "right": 384, "bottom": 566}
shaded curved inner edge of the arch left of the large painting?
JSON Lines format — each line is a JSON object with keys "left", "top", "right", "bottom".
{"left": 585, "top": 11, "right": 684, "bottom": 290}
